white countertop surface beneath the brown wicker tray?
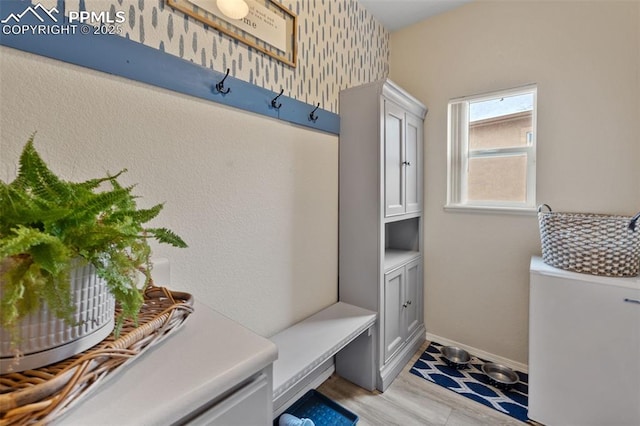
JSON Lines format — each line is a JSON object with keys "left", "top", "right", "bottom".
{"left": 56, "top": 302, "right": 278, "bottom": 426}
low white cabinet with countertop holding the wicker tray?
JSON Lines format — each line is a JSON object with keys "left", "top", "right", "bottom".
{"left": 54, "top": 301, "right": 278, "bottom": 426}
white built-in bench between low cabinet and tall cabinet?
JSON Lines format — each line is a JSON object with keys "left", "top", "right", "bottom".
{"left": 270, "top": 302, "right": 377, "bottom": 417}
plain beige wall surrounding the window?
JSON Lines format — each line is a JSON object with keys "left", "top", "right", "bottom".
{"left": 390, "top": 1, "right": 640, "bottom": 363}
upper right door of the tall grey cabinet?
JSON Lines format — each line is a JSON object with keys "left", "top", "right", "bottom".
{"left": 402, "top": 114, "right": 423, "bottom": 213}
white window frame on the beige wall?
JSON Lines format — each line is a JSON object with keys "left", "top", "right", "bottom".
{"left": 444, "top": 84, "right": 538, "bottom": 214}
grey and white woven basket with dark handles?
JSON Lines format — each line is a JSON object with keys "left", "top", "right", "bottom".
{"left": 538, "top": 204, "right": 640, "bottom": 277}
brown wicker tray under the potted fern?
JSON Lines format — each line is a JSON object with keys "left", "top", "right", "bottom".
{"left": 0, "top": 286, "right": 193, "bottom": 426}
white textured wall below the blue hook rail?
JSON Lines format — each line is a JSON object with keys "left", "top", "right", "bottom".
{"left": 0, "top": 47, "right": 338, "bottom": 338}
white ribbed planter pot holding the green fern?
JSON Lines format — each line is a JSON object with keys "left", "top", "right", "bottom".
{"left": 0, "top": 265, "right": 115, "bottom": 374}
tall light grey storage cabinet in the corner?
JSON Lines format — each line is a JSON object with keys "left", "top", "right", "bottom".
{"left": 336, "top": 80, "right": 427, "bottom": 391}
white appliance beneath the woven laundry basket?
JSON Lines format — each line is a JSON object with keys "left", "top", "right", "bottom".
{"left": 529, "top": 257, "right": 640, "bottom": 426}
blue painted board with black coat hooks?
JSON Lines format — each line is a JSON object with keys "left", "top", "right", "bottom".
{"left": 0, "top": 0, "right": 340, "bottom": 135}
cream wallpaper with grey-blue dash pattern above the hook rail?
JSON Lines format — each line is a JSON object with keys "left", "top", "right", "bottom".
{"left": 62, "top": 0, "right": 389, "bottom": 113}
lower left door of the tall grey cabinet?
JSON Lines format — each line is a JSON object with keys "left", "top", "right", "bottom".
{"left": 384, "top": 268, "right": 405, "bottom": 362}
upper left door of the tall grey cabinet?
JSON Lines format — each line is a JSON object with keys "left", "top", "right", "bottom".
{"left": 384, "top": 100, "right": 405, "bottom": 216}
